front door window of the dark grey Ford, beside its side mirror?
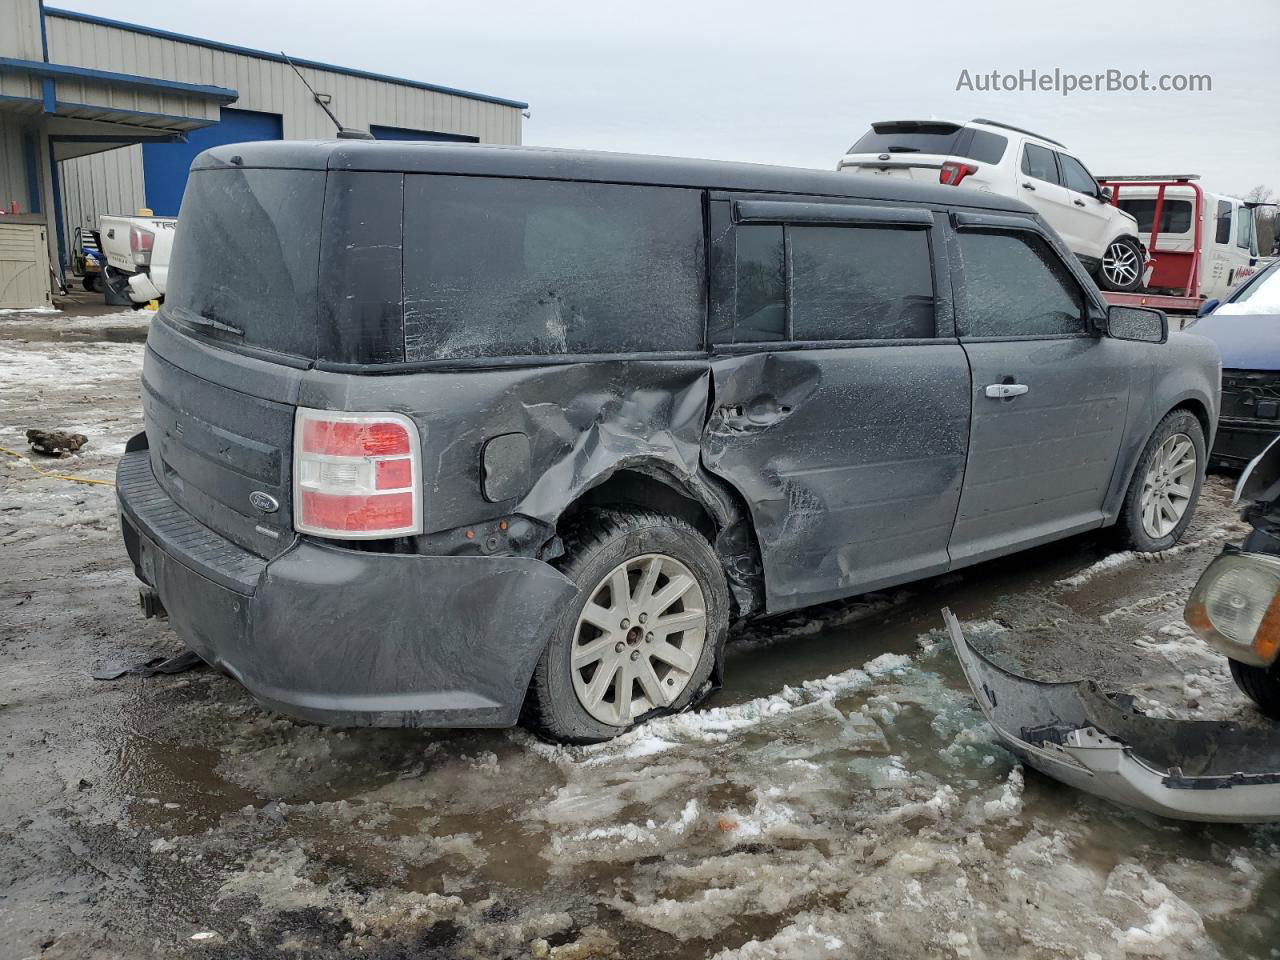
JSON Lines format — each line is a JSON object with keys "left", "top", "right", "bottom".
{"left": 960, "top": 230, "right": 1087, "bottom": 337}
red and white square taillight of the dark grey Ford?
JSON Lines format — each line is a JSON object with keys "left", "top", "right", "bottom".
{"left": 293, "top": 407, "right": 422, "bottom": 540}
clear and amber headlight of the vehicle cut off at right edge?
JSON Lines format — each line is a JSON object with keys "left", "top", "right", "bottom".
{"left": 1184, "top": 553, "right": 1280, "bottom": 667}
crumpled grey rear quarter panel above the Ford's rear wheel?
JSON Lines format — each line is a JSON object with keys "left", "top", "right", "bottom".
{"left": 298, "top": 360, "right": 710, "bottom": 534}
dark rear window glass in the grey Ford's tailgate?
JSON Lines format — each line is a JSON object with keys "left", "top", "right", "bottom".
{"left": 165, "top": 168, "right": 325, "bottom": 357}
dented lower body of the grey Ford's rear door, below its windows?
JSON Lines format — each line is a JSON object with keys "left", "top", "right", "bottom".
{"left": 703, "top": 342, "right": 969, "bottom": 612}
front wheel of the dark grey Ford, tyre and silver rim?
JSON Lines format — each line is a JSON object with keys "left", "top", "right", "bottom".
{"left": 1116, "top": 410, "right": 1204, "bottom": 553}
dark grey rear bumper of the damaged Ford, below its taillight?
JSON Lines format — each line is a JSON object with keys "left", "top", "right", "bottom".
{"left": 116, "top": 451, "right": 575, "bottom": 727}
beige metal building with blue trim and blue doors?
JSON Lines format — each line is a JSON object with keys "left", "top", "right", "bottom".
{"left": 0, "top": 0, "right": 529, "bottom": 307}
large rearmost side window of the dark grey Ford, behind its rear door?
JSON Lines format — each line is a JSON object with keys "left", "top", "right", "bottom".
{"left": 404, "top": 174, "right": 705, "bottom": 360}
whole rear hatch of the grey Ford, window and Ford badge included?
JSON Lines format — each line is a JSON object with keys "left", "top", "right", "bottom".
{"left": 143, "top": 154, "right": 326, "bottom": 557}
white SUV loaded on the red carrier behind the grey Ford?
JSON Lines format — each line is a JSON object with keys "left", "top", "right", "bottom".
{"left": 836, "top": 119, "right": 1146, "bottom": 291}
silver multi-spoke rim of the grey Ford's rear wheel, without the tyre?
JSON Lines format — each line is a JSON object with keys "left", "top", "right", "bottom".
{"left": 570, "top": 553, "right": 707, "bottom": 727}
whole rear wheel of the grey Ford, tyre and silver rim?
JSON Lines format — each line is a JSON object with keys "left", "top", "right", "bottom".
{"left": 525, "top": 509, "right": 728, "bottom": 744}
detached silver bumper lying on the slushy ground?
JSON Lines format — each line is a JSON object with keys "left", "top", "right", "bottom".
{"left": 942, "top": 611, "right": 1280, "bottom": 823}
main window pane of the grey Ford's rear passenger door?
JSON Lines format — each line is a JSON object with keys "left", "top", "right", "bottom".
{"left": 787, "top": 227, "right": 934, "bottom": 340}
